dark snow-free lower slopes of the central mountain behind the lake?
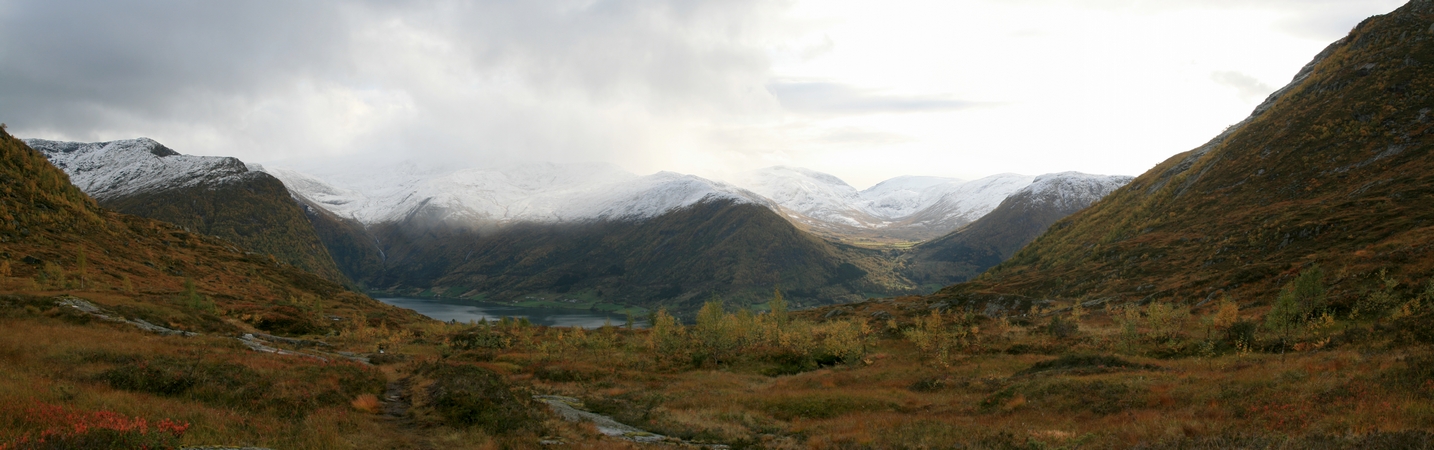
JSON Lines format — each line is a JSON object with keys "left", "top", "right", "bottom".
{"left": 360, "top": 199, "right": 912, "bottom": 312}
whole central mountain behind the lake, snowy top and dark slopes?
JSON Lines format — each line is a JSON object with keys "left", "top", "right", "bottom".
{"left": 262, "top": 163, "right": 913, "bottom": 311}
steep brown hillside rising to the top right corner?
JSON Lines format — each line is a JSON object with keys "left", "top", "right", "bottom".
{"left": 935, "top": 1, "right": 1434, "bottom": 312}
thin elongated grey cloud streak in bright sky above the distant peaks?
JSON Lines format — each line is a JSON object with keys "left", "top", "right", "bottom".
{"left": 767, "top": 80, "right": 982, "bottom": 116}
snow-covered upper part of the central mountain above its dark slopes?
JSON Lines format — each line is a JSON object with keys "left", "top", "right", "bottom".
{"left": 257, "top": 163, "right": 774, "bottom": 225}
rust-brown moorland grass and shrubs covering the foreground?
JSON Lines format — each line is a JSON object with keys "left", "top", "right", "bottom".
{"left": 0, "top": 265, "right": 1434, "bottom": 449}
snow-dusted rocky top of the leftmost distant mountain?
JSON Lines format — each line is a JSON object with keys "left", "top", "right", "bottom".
{"left": 24, "top": 138, "right": 254, "bottom": 202}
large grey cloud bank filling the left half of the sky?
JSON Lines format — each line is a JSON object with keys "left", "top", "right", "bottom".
{"left": 0, "top": 0, "right": 787, "bottom": 162}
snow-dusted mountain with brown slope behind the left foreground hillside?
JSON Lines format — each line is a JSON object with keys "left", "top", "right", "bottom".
{"left": 24, "top": 138, "right": 346, "bottom": 282}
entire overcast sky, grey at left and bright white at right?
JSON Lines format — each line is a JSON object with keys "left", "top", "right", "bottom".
{"left": 0, "top": 0, "right": 1404, "bottom": 188}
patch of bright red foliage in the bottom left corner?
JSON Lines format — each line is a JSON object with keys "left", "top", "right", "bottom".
{"left": 0, "top": 401, "right": 189, "bottom": 450}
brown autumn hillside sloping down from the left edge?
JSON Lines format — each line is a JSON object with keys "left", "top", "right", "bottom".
{"left": 0, "top": 130, "right": 419, "bottom": 334}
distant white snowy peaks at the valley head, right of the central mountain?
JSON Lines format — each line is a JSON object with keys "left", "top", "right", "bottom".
{"left": 736, "top": 166, "right": 1034, "bottom": 241}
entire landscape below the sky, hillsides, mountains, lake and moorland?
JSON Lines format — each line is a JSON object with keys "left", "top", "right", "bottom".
{"left": 0, "top": 0, "right": 1434, "bottom": 450}
